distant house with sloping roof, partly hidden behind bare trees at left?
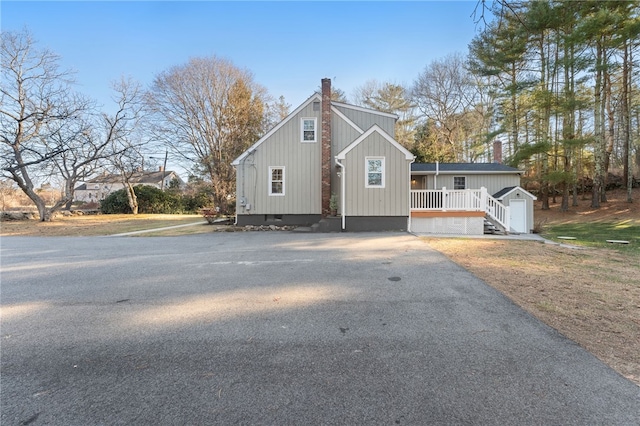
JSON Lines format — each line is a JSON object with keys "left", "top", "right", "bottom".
{"left": 74, "top": 167, "right": 184, "bottom": 203}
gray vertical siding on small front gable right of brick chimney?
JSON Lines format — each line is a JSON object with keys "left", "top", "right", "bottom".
{"left": 344, "top": 133, "right": 410, "bottom": 216}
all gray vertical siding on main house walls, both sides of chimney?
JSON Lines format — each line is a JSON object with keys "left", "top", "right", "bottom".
{"left": 236, "top": 103, "right": 410, "bottom": 220}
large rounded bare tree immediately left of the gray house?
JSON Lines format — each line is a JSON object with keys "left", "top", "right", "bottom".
{"left": 147, "top": 56, "right": 267, "bottom": 211}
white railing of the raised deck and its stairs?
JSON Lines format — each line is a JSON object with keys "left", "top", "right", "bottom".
{"left": 411, "top": 187, "right": 510, "bottom": 232}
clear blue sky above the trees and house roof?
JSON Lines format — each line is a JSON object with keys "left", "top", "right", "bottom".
{"left": 0, "top": 0, "right": 490, "bottom": 110}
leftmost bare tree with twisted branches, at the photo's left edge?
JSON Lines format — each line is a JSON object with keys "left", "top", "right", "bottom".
{"left": 0, "top": 31, "right": 88, "bottom": 221}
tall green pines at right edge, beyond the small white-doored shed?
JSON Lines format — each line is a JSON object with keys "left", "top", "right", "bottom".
{"left": 467, "top": 0, "right": 640, "bottom": 210}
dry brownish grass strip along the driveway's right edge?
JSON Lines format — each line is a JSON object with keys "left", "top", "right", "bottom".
{"left": 425, "top": 238, "right": 640, "bottom": 385}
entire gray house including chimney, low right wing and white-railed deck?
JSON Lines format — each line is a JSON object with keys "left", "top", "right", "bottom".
{"left": 232, "top": 79, "right": 535, "bottom": 234}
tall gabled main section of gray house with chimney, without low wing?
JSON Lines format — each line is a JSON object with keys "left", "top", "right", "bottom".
{"left": 232, "top": 79, "right": 414, "bottom": 231}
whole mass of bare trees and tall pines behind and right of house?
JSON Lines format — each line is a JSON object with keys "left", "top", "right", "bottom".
{"left": 354, "top": 0, "right": 640, "bottom": 210}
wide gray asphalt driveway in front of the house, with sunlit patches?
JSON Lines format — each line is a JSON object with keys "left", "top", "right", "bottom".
{"left": 0, "top": 232, "right": 640, "bottom": 425}
